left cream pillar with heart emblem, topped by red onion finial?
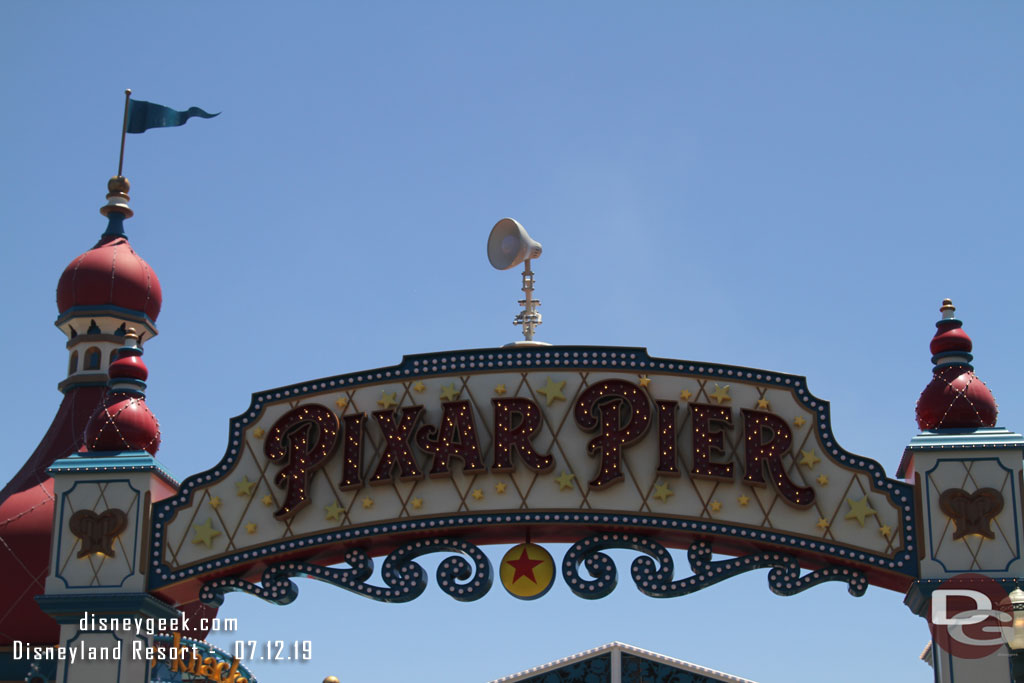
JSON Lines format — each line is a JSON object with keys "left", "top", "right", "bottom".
{"left": 36, "top": 328, "right": 178, "bottom": 683}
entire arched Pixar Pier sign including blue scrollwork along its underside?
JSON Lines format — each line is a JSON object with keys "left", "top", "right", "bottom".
{"left": 148, "top": 346, "right": 918, "bottom": 604}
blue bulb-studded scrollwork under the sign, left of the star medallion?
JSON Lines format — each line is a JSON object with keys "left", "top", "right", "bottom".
{"left": 200, "top": 539, "right": 494, "bottom": 606}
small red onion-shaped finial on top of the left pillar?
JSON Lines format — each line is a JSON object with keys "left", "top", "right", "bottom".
{"left": 85, "top": 328, "right": 160, "bottom": 456}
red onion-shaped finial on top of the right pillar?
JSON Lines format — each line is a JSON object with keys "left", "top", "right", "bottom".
{"left": 916, "top": 299, "right": 998, "bottom": 430}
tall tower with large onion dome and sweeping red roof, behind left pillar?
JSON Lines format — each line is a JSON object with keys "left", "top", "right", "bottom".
{"left": 0, "top": 177, "right": 161, "bottom": 675}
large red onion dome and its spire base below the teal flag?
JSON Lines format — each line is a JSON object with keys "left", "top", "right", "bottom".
{"left": 57, "top": 177, "right": 163, "bottom": 322}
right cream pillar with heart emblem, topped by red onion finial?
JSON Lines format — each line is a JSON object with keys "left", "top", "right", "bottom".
{"left": 897, "top": 299, "right": 1024, "bottom": 683}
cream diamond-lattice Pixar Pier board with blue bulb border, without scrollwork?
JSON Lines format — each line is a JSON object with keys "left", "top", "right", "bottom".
{"left": 153, "top": 347, "right": 917, "bottom": 583}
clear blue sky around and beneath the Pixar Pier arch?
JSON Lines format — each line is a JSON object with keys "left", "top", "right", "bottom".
{"left": 0, "top": 0, "right": 1024, "bottom": 683}
